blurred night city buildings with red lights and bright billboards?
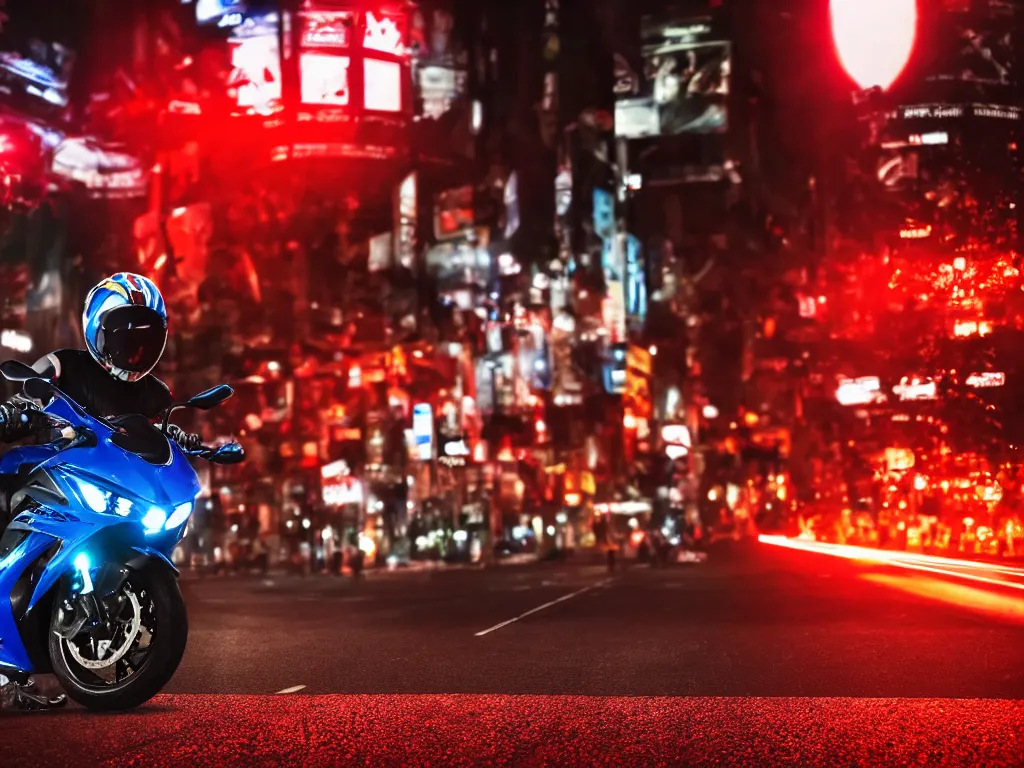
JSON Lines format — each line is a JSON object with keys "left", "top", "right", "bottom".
{"left": 0, "top": 0, "right": 1021, "bottom": 559}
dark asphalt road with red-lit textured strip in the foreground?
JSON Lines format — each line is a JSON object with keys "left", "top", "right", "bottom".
{"left": 0, "top": 545, "right": 1024, "bottom": 766}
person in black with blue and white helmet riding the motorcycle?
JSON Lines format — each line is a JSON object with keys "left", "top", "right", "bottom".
{"left": 0, "top": 272, "right": 202, "bottom": 706}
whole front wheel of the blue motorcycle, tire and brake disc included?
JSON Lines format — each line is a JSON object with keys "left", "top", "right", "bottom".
{"left": 49, "top": 567, "right": 188, "bottom": 712}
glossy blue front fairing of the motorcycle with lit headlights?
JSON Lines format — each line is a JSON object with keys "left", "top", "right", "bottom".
{"left": 0, "top": 398, "right": 200, "bottom": 673}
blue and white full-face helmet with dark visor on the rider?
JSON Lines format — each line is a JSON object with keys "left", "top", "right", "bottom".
{"left": 82, "top": 272, "right": 167, "bottom": 381}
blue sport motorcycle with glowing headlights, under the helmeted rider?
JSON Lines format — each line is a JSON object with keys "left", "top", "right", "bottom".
{"left": 0, "top": 360, "right": 245, "bottom": 711}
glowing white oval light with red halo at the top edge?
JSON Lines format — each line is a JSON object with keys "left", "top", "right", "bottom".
{"left": 829, "top": 0, "right": 918, "bottom": 90}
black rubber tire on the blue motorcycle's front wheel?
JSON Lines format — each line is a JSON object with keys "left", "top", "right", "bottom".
{"left": 49, "top": 566, "right": 188, "bottom": 712}
